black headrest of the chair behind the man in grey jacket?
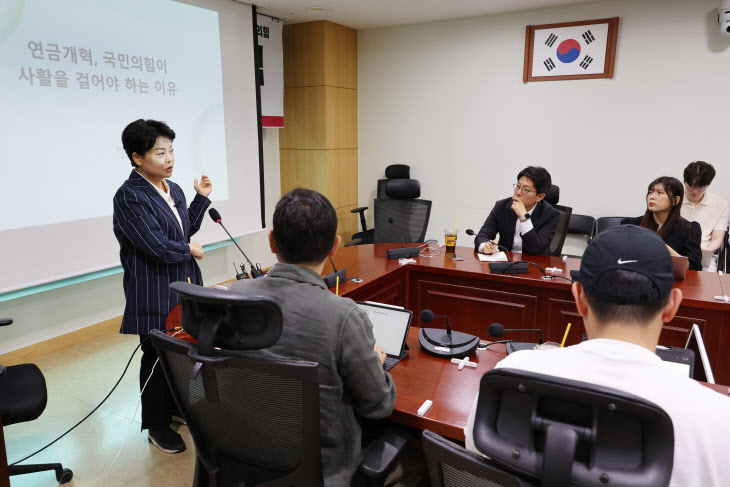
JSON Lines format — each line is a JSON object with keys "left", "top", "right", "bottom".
{"left": 170, "top": 282, "right": 283, "bottom": 353}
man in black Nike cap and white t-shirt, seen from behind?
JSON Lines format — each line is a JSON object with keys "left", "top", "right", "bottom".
{"left": 464, "top": 225, "right": 730, "bottom": 487}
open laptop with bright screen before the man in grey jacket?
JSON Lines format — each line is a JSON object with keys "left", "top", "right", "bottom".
{"left": 357, "top": 301, "right": 413, "bottom": 371}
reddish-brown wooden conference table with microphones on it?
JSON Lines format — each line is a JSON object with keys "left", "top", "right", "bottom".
{"left": 331, "top": 244, "right": 730, "bottom": 441}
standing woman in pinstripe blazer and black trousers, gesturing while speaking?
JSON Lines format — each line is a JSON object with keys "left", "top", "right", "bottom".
{"left": 113, "top": 119, "right": 213, "bottom": 453}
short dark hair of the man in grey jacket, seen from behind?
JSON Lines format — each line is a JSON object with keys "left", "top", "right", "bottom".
{"left": 274, "top": 188, "right": 337, "bottom": 264}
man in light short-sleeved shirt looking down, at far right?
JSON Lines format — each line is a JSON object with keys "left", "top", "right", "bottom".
{"left": 681, "top": 161, "right": 728, "bottom": 271}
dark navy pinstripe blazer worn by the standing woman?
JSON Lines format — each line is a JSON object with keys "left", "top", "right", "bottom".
{"left": 113, "top": 170, "right": 210, "bottom": 335}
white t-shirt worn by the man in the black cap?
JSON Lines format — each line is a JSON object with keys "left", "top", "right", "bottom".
{"left": 464, "top": 339, "right": 730, "bottom": 487}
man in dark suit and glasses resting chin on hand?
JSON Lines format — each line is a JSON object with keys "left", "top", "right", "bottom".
{"left": 474, "top": 166, "right": 560, "bottom": 255}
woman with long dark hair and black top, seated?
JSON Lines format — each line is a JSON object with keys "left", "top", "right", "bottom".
{"left": 621, "top": 176, "right": 702, "bottom": 271}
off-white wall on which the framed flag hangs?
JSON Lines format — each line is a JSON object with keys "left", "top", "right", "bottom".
{"left": 358, "top": 0, "right": 730, "bottom": 250}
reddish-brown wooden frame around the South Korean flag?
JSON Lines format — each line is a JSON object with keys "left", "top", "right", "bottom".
{"left": 522, "top": 17, "right": 618, "bottom": 83}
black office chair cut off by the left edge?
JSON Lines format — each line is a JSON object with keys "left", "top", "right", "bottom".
{"left": 0, "top": 319, "right": 73, "bottom": 484}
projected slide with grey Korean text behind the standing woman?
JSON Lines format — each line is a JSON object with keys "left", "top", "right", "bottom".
{"left": 0, "top": 0, "right": 229, "bottom": 231}
